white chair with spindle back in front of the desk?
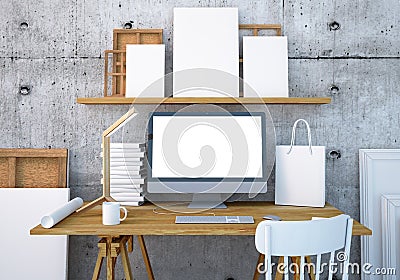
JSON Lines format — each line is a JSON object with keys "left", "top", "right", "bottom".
{"left": 255, "top": 215, "right": 353, "bottom": 280}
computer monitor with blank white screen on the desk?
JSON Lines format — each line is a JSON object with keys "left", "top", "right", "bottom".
{"left": 147, "top": 112, "right": 269, "bottom": 208}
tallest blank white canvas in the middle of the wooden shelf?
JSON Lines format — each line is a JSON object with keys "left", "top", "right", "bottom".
{"left": 173, "top": 8, "right": 239, "bottom": 97}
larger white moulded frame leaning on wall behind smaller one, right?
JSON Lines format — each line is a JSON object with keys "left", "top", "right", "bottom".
{"left": 359, "top": 149, "right": 400, "bottom": 280}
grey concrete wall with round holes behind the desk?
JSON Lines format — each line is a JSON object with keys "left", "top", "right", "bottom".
{"left": 0, "top": 0, "right": 400, "bottom": 279}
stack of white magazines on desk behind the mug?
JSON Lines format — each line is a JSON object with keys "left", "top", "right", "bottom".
{"left": 104, "top": 143, "right": 146, "bottom": 206}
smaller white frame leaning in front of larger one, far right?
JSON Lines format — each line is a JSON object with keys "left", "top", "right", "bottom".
{"left": 381, "top": 194, "right": 400, "bottom": 280}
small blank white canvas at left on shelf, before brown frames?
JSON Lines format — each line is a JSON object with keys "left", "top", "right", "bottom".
{"left": 125, "top": 44, "right": 165, "bottom": 97}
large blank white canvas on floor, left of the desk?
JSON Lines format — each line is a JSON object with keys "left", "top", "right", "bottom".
{"left": 0, "top": 188, "right": 69, "bottom": 280}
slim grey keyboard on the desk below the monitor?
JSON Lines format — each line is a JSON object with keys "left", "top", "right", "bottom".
{"left": 175, "top": 216, "right": 254, "bottom": 224}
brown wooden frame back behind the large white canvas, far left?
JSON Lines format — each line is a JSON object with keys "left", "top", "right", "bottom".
{"left": 0, "top": 149, "right": 68, "bottom": 188}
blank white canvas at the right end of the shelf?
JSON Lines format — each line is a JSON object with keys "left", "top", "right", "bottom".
{"left": 243, "top": 36, "right": 289, "bottom": 97}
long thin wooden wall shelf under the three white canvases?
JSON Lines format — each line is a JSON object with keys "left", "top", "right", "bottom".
{"left": 77, "top": 97, "right": 331, "bottom": 105}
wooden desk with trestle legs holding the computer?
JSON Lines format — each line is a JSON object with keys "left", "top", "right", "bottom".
{"left": 31, "top": 201, "right": 372, "bottom": 280}
